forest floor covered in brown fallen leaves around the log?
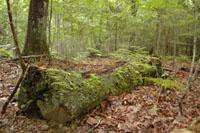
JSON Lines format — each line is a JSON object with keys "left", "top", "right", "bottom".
{"left": 0, "top": 59, "right": 200, "bottom": 133}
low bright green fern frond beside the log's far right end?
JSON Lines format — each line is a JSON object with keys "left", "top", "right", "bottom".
{"left": 144, "top": 77, "right": 185, "bottom": 90}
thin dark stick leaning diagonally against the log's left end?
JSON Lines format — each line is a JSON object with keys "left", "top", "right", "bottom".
{"left": 1, "top": 66, "right": 29, "bottom": 114}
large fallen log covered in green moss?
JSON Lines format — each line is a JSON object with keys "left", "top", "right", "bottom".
{"left": 18, "top": 62, "right": 162, "bottom": 123}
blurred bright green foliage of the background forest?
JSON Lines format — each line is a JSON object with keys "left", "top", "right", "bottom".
{"left": 0, "top": 0, "right": 197, "bottom": 58}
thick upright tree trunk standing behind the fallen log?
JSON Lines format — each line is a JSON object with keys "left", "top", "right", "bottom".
{"left": 23, "top": 0, "right": 49, "bottom": 55}
